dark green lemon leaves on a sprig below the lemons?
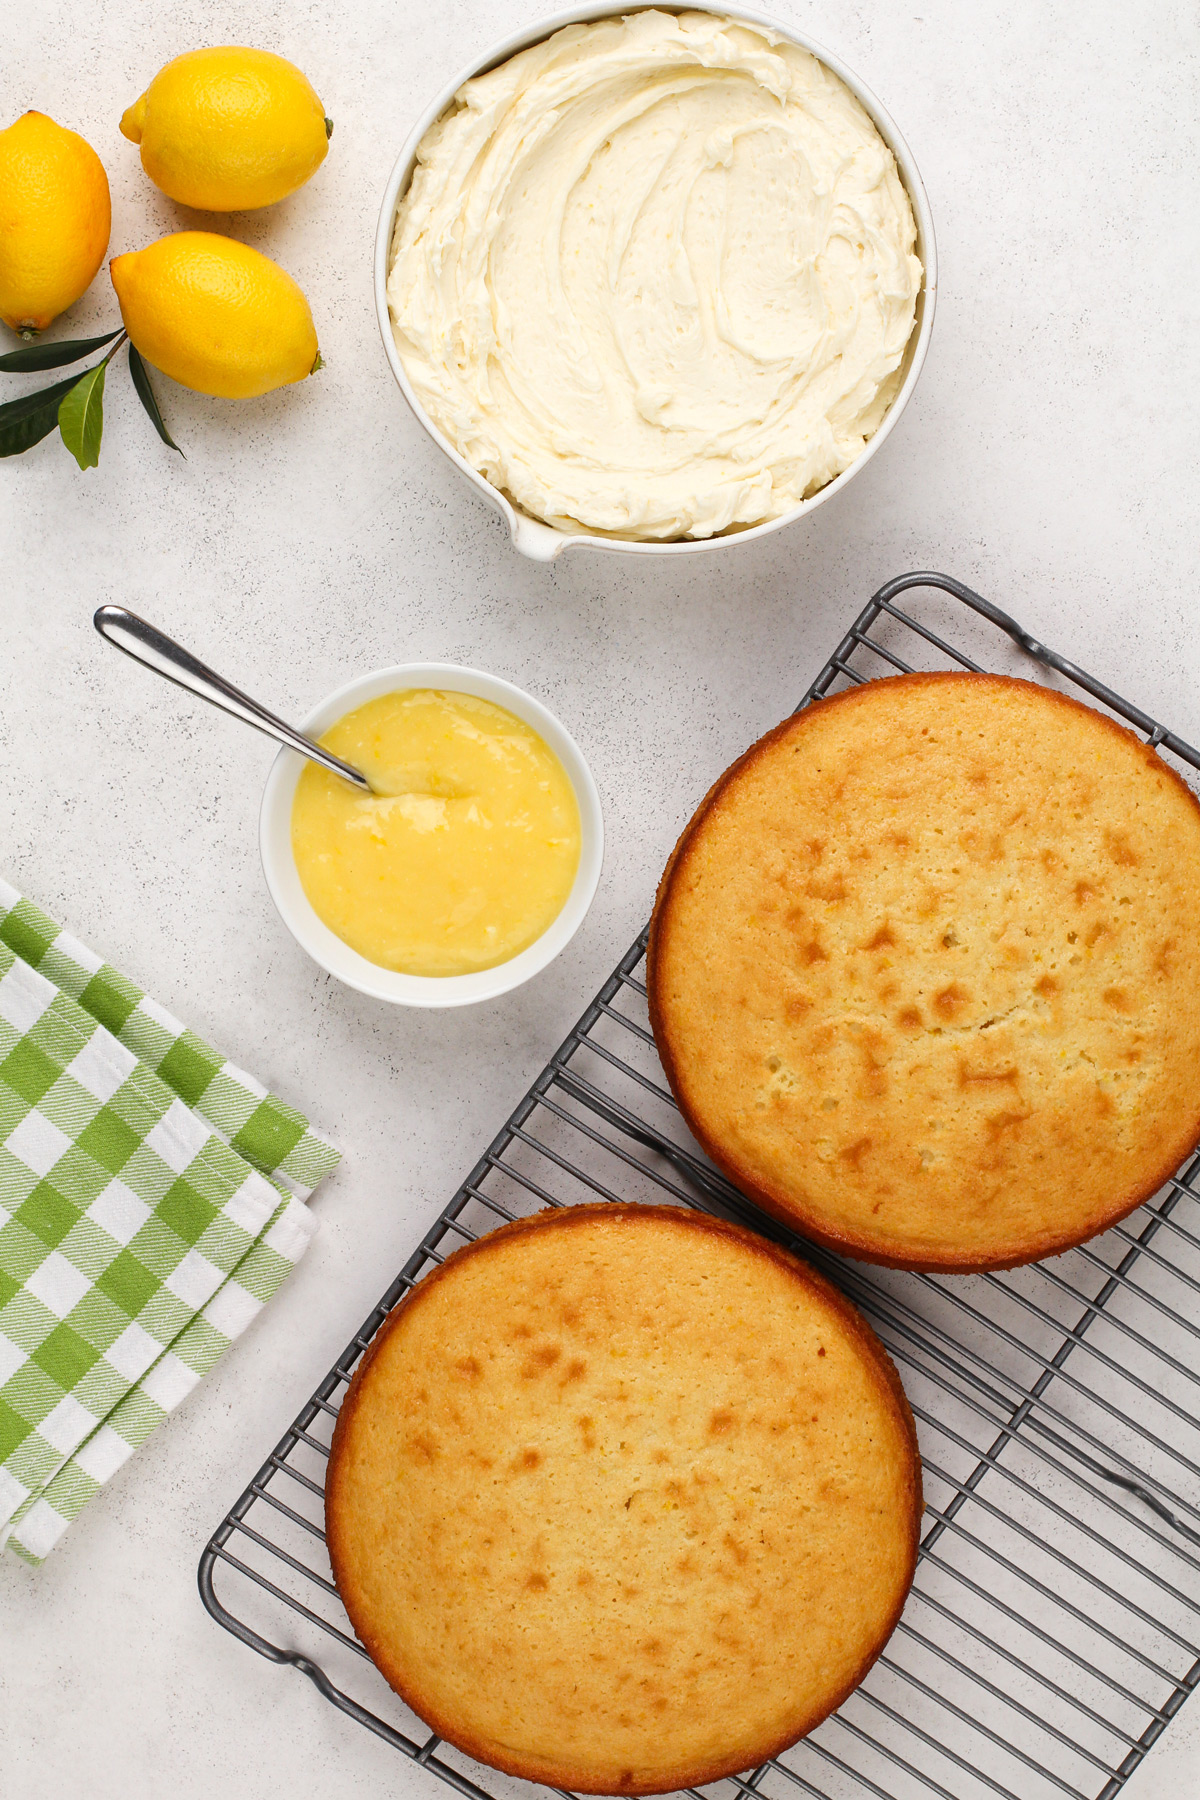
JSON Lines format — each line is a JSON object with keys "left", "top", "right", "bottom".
{"left": 0, "top": 329, "right": 184, "bottom": 468}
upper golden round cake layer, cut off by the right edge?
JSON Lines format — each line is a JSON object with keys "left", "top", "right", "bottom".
{"left": 648, "top": 675, "right": 1200, "bottom": 1269}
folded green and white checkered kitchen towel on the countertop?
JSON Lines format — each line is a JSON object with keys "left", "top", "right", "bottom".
{"left": 0, "top": 882, "right": 338, "bottom": 1562}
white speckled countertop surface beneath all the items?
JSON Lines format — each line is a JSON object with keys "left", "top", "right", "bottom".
{"left": 0, "top": 0, "right": 1200, "bottom": 1800}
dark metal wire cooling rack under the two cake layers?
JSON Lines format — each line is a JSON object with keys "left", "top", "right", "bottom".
{"left": 200, "top": 574, "right": 1200, "bottom": 1800}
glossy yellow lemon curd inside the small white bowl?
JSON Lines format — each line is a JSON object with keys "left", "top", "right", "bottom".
{"left": 291, "top": 688, "right": 579, "bottom": 976}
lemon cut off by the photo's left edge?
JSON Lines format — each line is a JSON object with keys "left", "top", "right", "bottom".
{"left": 0, "top": 112, "right": 112, "bottom": 335}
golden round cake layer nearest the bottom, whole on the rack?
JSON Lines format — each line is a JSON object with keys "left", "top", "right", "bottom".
{"left": 326, "top": 1206, "right": 921, "bottom": 1795}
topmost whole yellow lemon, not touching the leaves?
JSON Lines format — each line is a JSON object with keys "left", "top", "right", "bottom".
{"left": 121, "top": 45, "right": 333, "bottom": 212}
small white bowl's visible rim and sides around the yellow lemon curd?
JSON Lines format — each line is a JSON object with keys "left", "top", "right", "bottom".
{"left": 259, "top": 662, "right": 604, "bottom": 1006}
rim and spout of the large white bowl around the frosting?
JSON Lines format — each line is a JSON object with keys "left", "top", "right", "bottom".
{"left": 374, "top": 0, "right": 937, "bottom": 562}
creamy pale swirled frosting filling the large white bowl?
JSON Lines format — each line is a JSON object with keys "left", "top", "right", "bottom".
{"left": 389, "top": 11, "right": 921, "bottom": 538}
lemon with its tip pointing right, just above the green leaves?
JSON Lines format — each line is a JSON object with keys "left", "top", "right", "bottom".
{"left": 108, "top": 230, "right": 320, "bottom": 400}
